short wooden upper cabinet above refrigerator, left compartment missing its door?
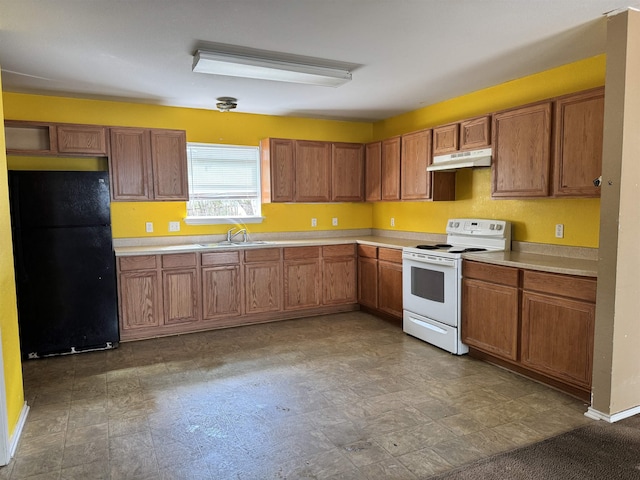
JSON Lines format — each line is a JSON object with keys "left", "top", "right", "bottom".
{"left": 5, "top": 120, "right": 109, "bottom": 157}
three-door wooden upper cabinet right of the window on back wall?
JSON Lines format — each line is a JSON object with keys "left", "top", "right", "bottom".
{"left": 260, "top": 138, "right": 364, "bottom": 203}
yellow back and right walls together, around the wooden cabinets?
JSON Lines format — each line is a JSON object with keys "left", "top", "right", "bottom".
{"left": 4, "top": 55, "right": 605, "bottom": 247}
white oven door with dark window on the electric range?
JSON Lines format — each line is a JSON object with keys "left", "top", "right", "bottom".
{"left": 402, "top": 256, "right": 460, "bottom": 327}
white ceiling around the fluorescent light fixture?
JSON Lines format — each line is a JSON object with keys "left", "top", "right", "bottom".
{"left": 0, "top": 0, "right": 640, "bottom": 121}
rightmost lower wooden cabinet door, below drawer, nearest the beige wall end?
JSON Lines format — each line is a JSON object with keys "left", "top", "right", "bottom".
{"left": 521, "top": 291, "right": 595, "bottom": 388}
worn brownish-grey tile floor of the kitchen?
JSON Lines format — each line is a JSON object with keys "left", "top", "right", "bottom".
{"left": 0, "top": 312, "right": 589, "bottom": 480}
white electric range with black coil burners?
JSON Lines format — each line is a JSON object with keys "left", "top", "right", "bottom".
{"left": 402, "top": 218, "right": 511, "bottom": 355}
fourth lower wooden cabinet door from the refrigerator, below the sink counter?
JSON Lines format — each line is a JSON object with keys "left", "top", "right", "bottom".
{"left": 244, "top": 248, "right": 282, "bottom": 314}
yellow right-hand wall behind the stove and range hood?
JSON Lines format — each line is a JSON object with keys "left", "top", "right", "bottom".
{"left": 373, "top": 55, "right": 605, "bottom": 247}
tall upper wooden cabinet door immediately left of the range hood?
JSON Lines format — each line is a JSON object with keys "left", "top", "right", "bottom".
{"left": 400, "top": 130, "right": 431, "bottom": 200}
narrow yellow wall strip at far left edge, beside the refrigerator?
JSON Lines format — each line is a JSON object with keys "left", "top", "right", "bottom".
{"left": 0, "top": 68, "right": 24, "bottom": 435}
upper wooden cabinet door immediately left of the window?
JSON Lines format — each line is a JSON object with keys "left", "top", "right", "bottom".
{"left": 150, "top": 130, "right": 189, "bottom": 201}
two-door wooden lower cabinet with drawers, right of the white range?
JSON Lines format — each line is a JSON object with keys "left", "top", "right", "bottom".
{"left": 462, "top": 260, "right": 596, "bottom": 400}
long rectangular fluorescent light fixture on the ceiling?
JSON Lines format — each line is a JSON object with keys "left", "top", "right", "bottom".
{"left": 193, "top": 50, "right": 351, "bottom": 87}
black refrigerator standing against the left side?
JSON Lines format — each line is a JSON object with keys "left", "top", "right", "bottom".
{"left": 9, "top": 171, "right": 119, "bottom": 358}
